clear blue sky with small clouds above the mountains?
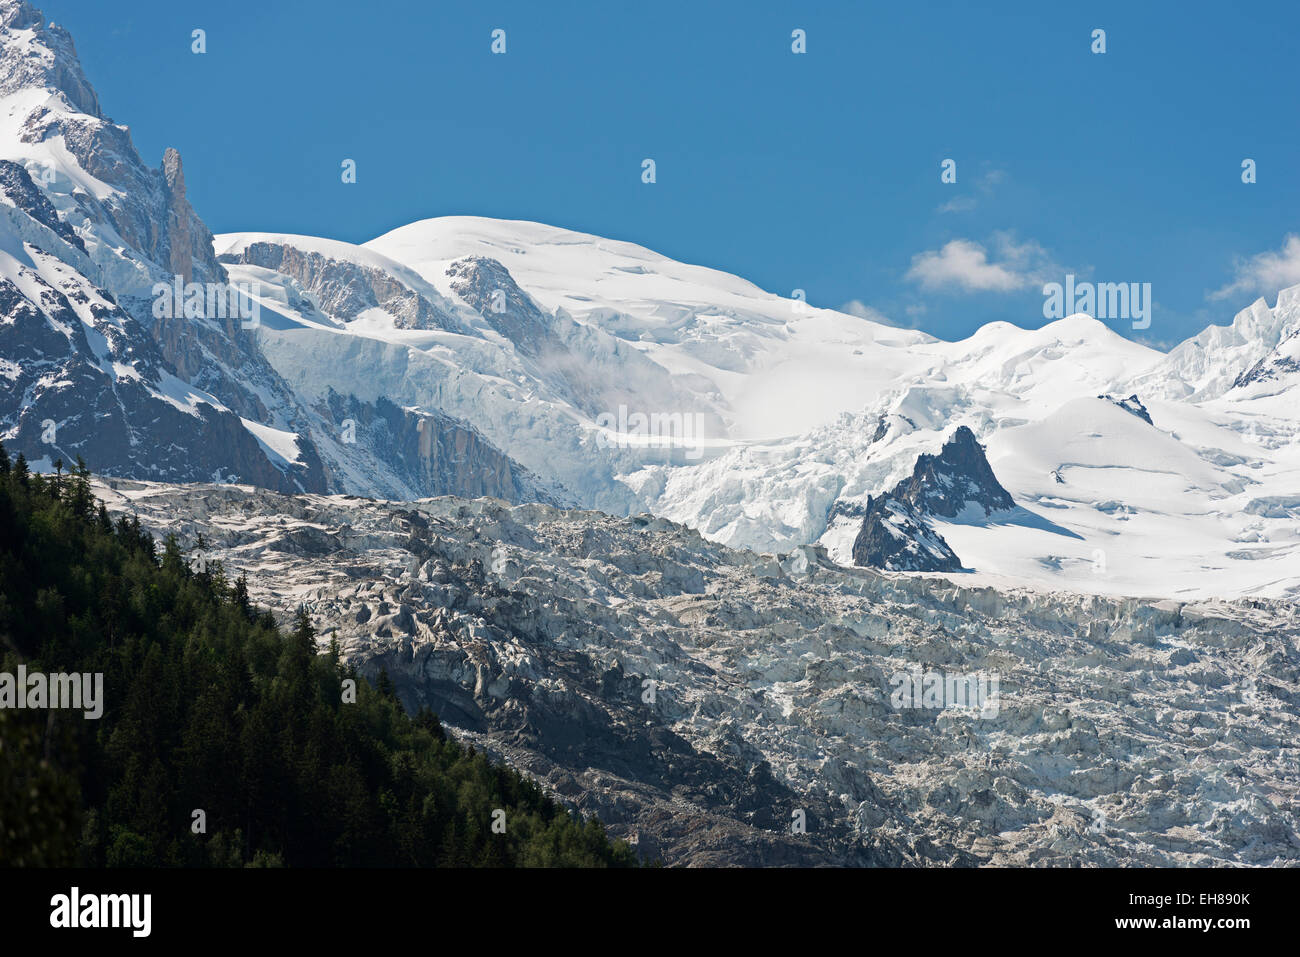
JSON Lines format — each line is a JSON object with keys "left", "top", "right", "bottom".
{"left": 38, "top": 0, "right": 1300, "bottom": 345}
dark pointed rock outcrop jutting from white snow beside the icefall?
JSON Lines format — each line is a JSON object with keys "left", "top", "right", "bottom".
{"left": 853, "top": 425, "right": 1015, "bottom": 572}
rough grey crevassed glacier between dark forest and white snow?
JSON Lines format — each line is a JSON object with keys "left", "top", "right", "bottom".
{"left": 103, "top": 484, "right": 1300, "bottom": 866}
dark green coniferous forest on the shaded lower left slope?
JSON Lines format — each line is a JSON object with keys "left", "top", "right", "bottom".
{"left": 0, "top": 446, "right": 637, "bottom": 867}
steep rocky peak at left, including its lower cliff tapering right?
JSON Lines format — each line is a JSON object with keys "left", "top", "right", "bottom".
{"left": 0, "top": 0, "right": 560, "bottom": 501}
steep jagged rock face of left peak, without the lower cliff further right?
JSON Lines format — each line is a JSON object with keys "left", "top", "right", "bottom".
{"left": 0, "top": 0, "right": 317, "bottom": 490}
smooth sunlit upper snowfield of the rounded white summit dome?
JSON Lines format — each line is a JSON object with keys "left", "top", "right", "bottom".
{"left": 365, "top": 216, "right": 931, "bottom": 441}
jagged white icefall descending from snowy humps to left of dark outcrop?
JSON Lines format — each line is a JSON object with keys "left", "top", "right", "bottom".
{"left": 655, "top": 316, "right": 1161, "bottom": 548}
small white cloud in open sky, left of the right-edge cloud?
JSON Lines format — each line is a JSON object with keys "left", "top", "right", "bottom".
{"left": 904, "top": 233, "right": 1061, "bottom": 293}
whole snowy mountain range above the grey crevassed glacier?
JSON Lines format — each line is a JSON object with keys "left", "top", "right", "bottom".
{"left": 0, "top": 0, "right": 1300, "bottom": 597}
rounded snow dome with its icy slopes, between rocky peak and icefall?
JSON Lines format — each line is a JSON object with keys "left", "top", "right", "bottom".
{"left": 216, "top": 217, "right": 931, "bottom": 511}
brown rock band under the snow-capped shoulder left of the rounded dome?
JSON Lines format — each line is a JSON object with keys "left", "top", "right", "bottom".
{"left": 221, "top": 242, "right": 462, "bottom": 332}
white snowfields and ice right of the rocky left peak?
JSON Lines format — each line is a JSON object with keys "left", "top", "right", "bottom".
{"left": 217, "top": 211, "right": 1300, "bottom": 594}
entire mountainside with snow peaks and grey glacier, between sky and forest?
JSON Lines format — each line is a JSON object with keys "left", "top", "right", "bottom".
{"left": 0, "top": 0, "right": 1300, "bottom": 866}
